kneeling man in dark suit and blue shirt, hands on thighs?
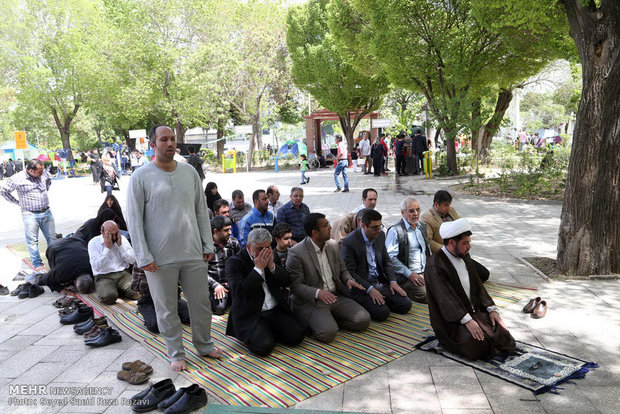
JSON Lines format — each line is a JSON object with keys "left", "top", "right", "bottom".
{"left": 342, "top": 209, "right": 411, "bottom": 322}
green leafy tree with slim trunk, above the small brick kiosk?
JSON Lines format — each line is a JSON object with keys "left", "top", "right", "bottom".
{"left": 287, "top": 0, "right": 389, "bottom": 149}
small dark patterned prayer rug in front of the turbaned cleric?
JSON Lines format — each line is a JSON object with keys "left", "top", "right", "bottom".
{"left": 416, "top": 336, "right": 598, "bottom": 394}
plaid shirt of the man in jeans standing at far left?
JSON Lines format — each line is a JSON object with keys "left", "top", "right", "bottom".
{"left": 0, "top": 170, "right": 52, "bottom": 211}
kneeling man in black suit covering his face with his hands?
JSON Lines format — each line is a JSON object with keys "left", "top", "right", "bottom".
{"left": 226, "top": 228, "right": 304, "bottom": 356}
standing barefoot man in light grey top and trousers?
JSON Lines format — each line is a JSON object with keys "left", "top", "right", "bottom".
{"left": 127, "top": 125, "right": 222, "bottom": 371}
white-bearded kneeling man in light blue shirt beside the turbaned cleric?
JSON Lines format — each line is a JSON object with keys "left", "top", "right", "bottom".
{"left": 385, "top": 197, "right": 431, "bottom": 303}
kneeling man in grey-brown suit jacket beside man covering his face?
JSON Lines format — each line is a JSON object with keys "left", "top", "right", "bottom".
{"left": 286, "top": 213, "right": 370, "bottom": 342}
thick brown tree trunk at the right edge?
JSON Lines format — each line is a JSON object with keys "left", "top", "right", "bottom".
{"left": 557, "top": 0, "right": 620, "bottom": 275}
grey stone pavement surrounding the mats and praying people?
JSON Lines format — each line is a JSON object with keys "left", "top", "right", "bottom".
{"left": 0, "top": 169, "right": 620, "bottom": 414}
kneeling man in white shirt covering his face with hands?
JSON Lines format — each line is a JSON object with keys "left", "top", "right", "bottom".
{"left": 88, "top": 220, "right": 140, "bottom": 305}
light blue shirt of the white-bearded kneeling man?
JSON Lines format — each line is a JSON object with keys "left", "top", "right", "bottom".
{"left": 385, "top": 220, "right": 426, "bottom": 277}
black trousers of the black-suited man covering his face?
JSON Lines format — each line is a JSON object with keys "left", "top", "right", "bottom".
{"left": 245, "top": 306, "right": 305, "bottom": 356}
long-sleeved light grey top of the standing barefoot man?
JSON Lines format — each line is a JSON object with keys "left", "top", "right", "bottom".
{"left": 127, "top": 162, "right": 214, "bottom": 267}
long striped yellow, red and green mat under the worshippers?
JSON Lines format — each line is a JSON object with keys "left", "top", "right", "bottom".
{"left": 109, "top": 282, "right": 536, "bottom": 407}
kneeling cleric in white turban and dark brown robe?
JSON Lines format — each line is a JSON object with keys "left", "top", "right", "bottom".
{"left": 424, "top": 219, "right": 515, "bottom": 360}
